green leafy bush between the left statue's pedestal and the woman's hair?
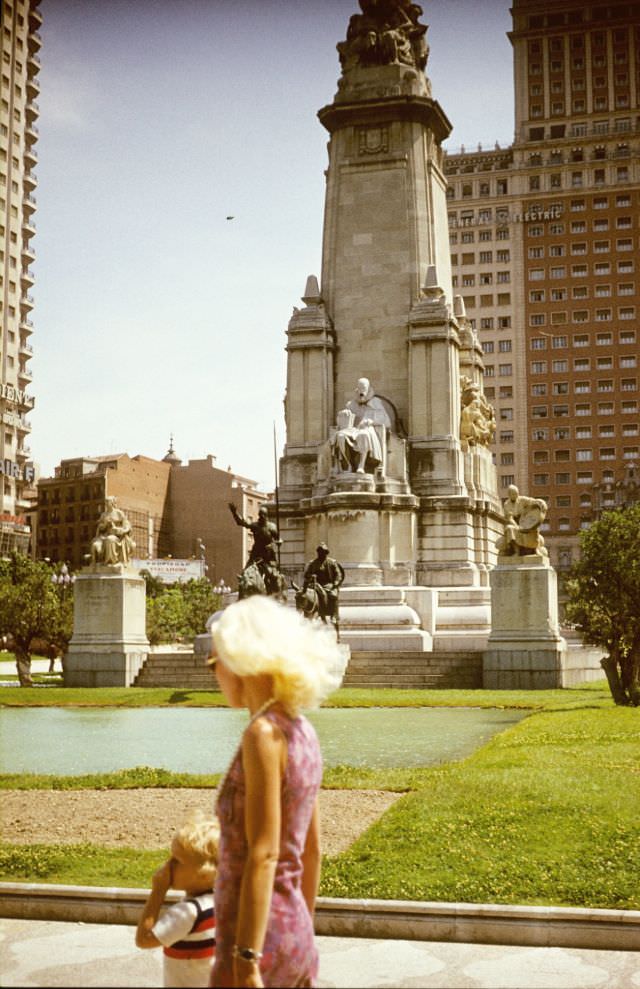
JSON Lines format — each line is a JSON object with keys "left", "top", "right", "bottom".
{"left": 141, "top": 570, "right": 220, "bottom": 645}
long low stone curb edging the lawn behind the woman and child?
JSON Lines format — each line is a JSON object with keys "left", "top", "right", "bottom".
{"left": 0, "top": 883, "right": 640, "bottom": 951}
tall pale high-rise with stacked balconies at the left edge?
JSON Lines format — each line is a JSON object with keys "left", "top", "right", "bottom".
{"left": 0, "top": 0, "right": 42, "bottom": 555}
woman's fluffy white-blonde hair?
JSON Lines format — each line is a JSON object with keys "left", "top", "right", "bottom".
{"left": 211, "top": 594, "right": 346, "bottom": 715}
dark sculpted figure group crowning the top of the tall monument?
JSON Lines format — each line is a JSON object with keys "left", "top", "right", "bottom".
{"left": 337, "top": 0, "right": 429, "bottom": 71}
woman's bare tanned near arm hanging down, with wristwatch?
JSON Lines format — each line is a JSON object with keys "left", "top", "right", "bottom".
{"left": 235, "top": 718, "right": 287, "bottom": 986}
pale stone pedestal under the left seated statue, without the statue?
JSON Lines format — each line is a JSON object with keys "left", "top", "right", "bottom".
{"left": 64, "top": 564, "right": 149, "bottom": 687}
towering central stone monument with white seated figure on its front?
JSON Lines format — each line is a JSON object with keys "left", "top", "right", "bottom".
{"left": 279, "top": 0, "right": 503, "bottom": 653}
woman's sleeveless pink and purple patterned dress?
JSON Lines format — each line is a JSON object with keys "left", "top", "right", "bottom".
{"left": 209, "top": 708, "right": 322, "bottom": 989}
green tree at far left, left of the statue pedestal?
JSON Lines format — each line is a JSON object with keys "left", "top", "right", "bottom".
{"left": 0, "top": 552, "right": 73, "bottom": 687}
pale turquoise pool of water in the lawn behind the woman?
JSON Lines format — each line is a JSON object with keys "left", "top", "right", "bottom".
{"left": 0, "top": 708, "right": 526, "bottom": 776}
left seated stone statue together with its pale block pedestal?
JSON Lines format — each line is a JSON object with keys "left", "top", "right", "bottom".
{"left": 64, "top": 497, "right": 149, "bottom": 687}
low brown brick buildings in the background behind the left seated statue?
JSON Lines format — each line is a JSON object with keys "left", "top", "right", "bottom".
{"left": 34, "top": 450, "right": 267, "bottom": 587}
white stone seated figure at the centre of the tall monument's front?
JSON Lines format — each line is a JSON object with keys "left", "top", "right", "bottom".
{"left": 332, "top": 378, "right": 391, "bottom": 474}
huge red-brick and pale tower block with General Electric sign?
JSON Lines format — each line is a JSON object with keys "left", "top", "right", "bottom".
{"left": 446, "top": 0, "right": 640, "bottom": 570}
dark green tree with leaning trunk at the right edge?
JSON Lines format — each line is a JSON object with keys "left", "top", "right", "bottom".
{"left": 566, "top": 502, "right": 640, "bottom": 707}
